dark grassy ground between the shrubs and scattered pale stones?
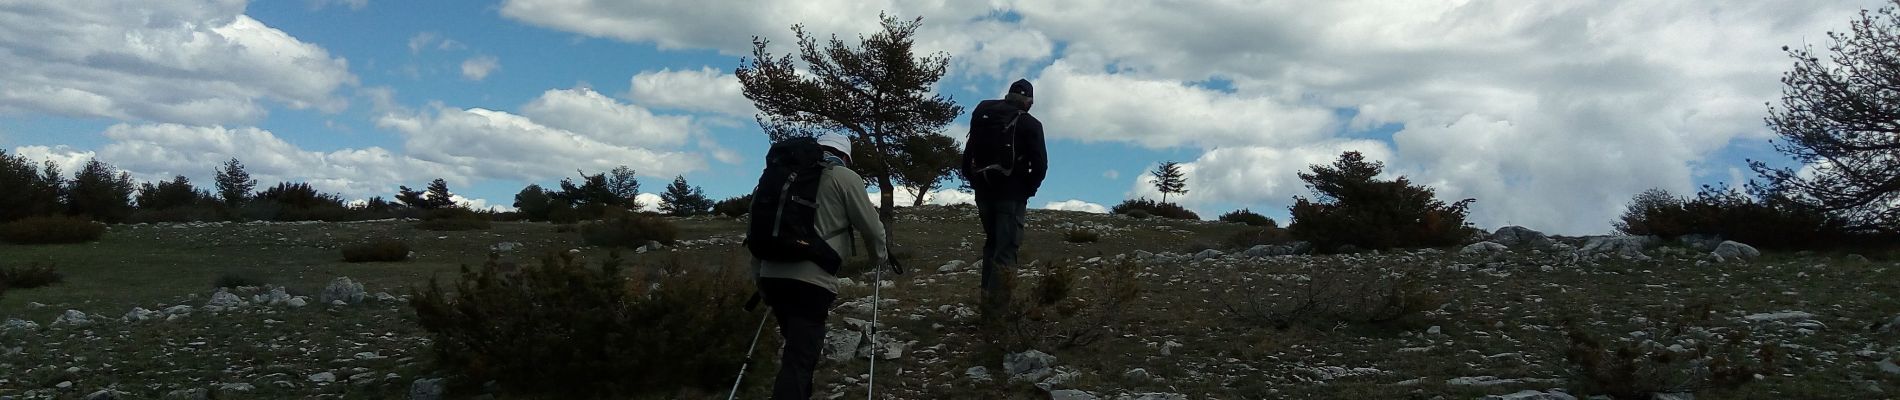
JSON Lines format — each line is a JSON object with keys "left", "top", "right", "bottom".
{"left": 0, "top": 207, "right": 1900, "bottom": 398}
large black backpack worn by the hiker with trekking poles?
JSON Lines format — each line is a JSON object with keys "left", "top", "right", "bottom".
{"left": 745, "top": 138, "right": 844, "bottom": 275}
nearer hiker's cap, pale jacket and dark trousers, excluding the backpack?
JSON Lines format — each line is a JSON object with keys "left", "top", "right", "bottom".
{"left": 752, "top": 135, "right": 891, "bottom": 400}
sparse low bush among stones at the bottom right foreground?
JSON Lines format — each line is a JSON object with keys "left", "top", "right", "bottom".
{"left": 1564, "top": 305, "right": 1780, "bottom": 398}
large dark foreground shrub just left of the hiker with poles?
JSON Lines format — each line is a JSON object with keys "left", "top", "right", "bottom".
{"left": 410, "top": 252, "right": 779, "bottom": 398}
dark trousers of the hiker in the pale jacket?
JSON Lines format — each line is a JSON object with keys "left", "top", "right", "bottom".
{"left": 758, "top": 279, "right": 838, "bottom": 400}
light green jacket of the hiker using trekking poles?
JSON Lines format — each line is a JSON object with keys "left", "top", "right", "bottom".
{"left": 752, "top": 165, "right": 889, "bottom": 294}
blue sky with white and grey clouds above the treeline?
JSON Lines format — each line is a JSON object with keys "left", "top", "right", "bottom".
{"left": 0, "top": 0, "right": 1883, "bottom": 233}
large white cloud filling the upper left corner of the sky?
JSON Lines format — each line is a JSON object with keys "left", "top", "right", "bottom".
{"left": 0, "top": 0, "right": 357, "bottom": 125}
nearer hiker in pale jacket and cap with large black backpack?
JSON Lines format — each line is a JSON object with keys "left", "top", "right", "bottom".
{"left": 741, "top": 135, "right": 901, "bottom": 400}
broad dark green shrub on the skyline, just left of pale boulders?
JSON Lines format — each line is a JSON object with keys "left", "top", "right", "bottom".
{"left": 1286, "top": 152, "right": 1474, "bottom": 252}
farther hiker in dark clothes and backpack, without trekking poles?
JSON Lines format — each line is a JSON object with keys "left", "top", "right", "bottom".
{"left": 960, "top": 80, "right": 1049, "bottom": 315}
